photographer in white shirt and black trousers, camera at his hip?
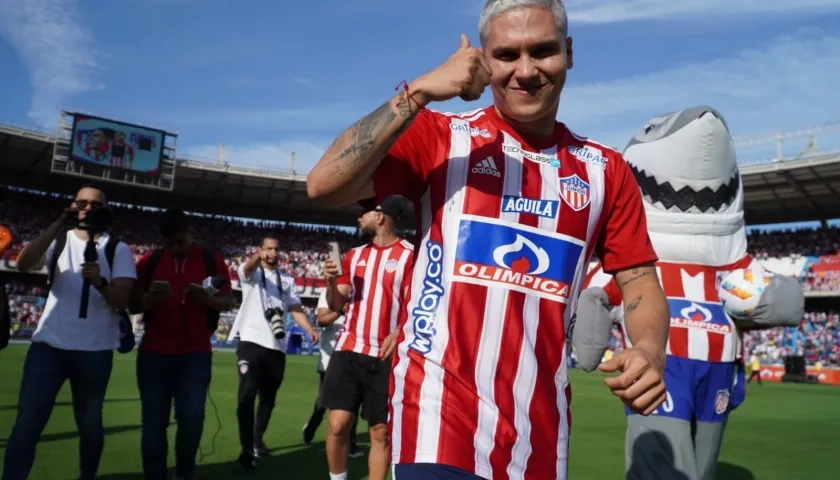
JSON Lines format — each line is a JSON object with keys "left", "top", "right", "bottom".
{"left": 229, "top": 235, "right": 318, "bottom": 470}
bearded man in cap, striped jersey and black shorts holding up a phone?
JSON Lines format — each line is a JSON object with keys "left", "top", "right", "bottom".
{"left": 321, "top": 196, "right": 414, "bottom": 480}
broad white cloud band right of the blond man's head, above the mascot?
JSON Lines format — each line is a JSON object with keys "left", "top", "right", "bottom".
{"left": 559, "top": 31, "right": 840, "bottom": 159}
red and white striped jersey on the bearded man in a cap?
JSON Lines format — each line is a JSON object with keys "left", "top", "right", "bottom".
{"left": 335, "top": 240, "right": 414, "bottom": 357}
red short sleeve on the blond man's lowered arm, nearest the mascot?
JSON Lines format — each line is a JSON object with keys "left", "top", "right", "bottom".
{"left": 595, "top": 155, "right": 657, "bottom": 274}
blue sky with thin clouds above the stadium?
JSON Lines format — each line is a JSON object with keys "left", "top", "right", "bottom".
{"left": 0, "top": 0, "right": 840, "bottom": 178}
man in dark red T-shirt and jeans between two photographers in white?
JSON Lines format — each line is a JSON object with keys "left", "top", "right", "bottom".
{"left": 135, "top": 209, "right": 233, "bottom": 480}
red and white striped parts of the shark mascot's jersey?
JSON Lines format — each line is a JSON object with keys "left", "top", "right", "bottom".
{"left": 587, "top": 256, "right": 755, "bottom": 362}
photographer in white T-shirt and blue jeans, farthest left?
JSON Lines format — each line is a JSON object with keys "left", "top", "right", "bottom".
{"left": 2, "top": 186, "right": 137, "bottom": 480}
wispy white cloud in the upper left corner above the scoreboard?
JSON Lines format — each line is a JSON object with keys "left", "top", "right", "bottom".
{"left": 0, "top": 0, "right": 101, "bottom": 126}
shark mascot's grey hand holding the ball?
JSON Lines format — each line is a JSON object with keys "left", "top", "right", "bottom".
{"left": 734, "top": 275, "right": 805, "bottom": 330}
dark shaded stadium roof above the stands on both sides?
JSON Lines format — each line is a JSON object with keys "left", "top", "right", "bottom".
{"left": 0, "top": 121, "right": 840, "bottom": 227}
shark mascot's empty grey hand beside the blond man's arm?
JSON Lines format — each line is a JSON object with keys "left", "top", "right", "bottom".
{"left": 572, "top": 287, "right": 613, "bottom": 372}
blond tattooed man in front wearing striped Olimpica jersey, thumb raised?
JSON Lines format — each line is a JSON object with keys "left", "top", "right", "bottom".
{"left": 307, "top": 0, "right": 668, "bottom": 480}
